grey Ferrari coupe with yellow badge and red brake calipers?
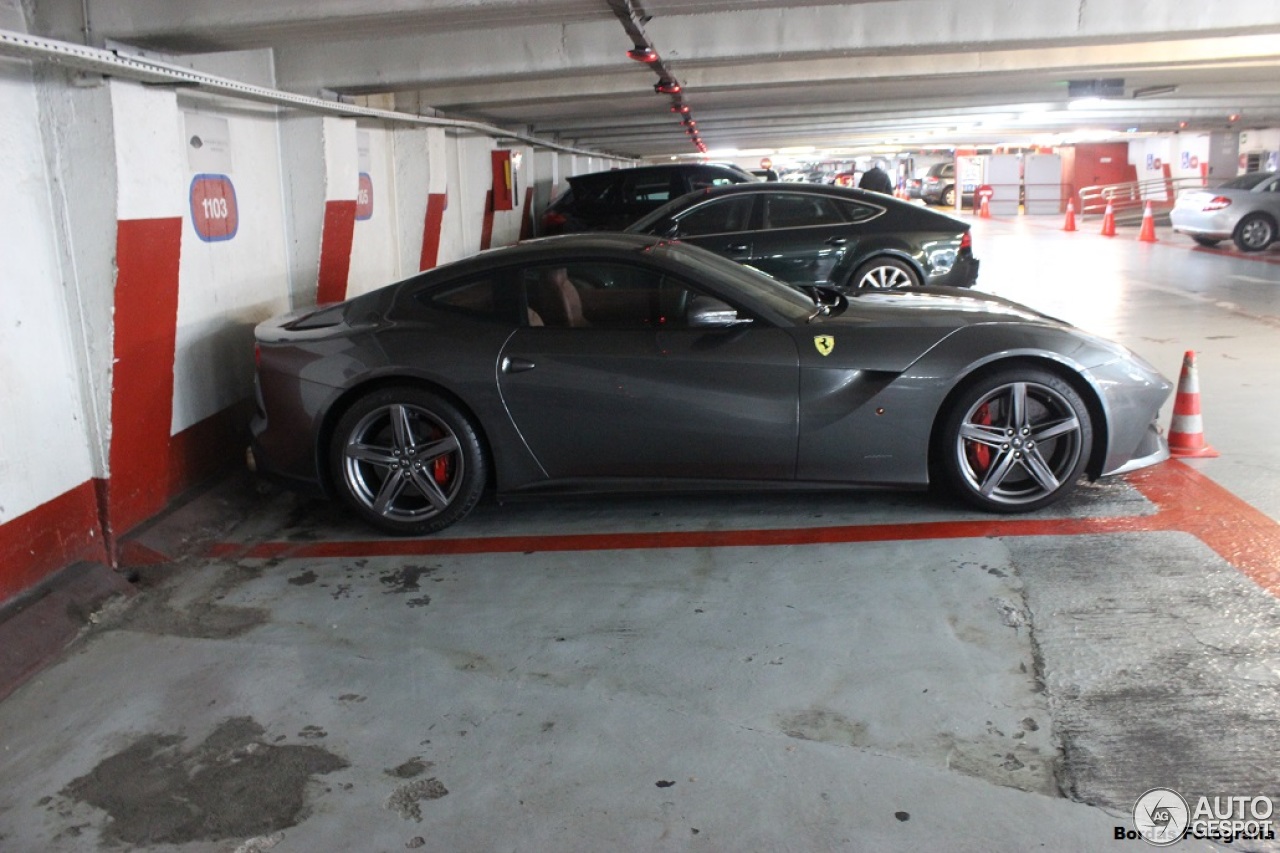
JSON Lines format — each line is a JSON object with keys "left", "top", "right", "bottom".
{"left": 251, "top": 234, "right": 1170, "bottom": 534}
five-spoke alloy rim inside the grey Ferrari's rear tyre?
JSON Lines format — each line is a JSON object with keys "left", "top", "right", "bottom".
{"left": 342, "top": 402, "right": 466, "bottom": 523}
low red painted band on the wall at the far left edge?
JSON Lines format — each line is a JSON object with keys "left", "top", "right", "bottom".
{"left": 0, "top": 480, "right": 106, "bottom": 602}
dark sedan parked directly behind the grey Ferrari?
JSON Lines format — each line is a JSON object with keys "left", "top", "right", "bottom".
{"left": 627, "top": 183, "right": 978, "bottom": 291}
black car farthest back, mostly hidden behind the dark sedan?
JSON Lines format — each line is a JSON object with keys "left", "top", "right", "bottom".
{"left": 541, "top": 163, "right": 756, "bottom": 236}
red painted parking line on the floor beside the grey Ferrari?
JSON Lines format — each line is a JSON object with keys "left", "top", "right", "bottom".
{"left": 197, "top": 461, "right": 1280, "bottom": 598}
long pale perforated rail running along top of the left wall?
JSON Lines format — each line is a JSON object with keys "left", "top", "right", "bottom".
{"left": 0, "top": 29, "right": 635, "bottom": 161}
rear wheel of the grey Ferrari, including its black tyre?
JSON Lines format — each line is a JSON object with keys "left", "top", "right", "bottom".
{"left": 329, "top": 387, "right": 488, "bottom": 535}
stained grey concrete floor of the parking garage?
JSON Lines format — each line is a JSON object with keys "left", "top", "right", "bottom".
{"left": 0, "top": 213, "right": 1280, "bottom": 852}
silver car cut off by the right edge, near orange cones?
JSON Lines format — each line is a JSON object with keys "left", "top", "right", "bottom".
{"left": 1169, "top": 172, "right": 1280, "bottom": 252}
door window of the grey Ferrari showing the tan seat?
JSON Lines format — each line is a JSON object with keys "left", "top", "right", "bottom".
{"left": 520, "top": 261, "right": 692, "bottom": 330}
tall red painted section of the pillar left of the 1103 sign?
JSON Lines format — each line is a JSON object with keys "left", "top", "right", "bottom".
{"left": 104, "top": 216, "right": 182, "bottom": 543}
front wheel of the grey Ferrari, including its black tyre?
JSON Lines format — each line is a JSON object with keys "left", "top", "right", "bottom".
{"left": 941, "top": 368, "right": 1093, "bottom": 512}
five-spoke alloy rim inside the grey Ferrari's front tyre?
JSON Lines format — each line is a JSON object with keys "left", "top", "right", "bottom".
{"left": 952, "top": 382, "right": 1084, "bottom": 507}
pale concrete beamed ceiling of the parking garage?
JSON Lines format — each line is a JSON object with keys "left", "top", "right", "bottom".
{"left": 33, "top": 0, "right": 1280, "bottom": 158}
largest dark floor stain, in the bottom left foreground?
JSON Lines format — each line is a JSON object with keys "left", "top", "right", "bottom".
{"left": 60, "top": 717, "right": 348, "bottom": 844}
